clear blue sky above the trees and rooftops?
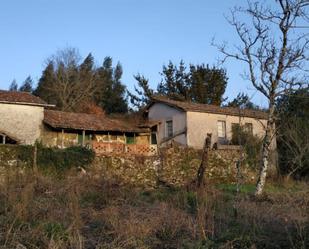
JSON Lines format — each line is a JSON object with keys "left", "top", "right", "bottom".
{"left": 0, "top": 0, "right": 265, "bottom": 105}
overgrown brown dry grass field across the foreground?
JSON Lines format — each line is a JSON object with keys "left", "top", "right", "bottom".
{"left": 0, "top": 167, "right": 309, "bottom": 249}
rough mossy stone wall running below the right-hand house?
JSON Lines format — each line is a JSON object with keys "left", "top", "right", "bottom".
{"left": 90, "top": 147, "right": 256, "bottom": 187}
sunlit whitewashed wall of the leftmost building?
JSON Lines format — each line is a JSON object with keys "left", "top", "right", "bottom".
{"left": 0, "top": 103, "right": 44, "bottom": 144}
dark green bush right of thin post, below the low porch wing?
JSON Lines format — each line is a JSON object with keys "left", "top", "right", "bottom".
{"left": 38, "top": 146, "right": 95, "bottom": 170}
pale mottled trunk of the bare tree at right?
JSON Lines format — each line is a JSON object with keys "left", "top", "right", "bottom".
{"left": 255, "top": 103, "right": 275, "bottom": 196}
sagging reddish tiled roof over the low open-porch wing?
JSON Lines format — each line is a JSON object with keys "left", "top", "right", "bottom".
{"left": 44, "top": 110, "right": 148, "bottom": 132}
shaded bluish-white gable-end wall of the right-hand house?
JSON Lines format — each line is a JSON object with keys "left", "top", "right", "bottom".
{"left": 148, "top": 103, "right": 187, "bottom": 145}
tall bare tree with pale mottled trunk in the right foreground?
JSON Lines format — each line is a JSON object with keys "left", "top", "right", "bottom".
{"left": 214, "top": 0, "right": 309, "bottom": 196}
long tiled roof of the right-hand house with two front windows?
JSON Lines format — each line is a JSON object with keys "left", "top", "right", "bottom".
{"left": 148, "top": 96, "right": 267, "bottom": 119}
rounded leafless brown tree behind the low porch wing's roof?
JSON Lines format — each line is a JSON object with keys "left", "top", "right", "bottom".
{"left": 39, "top": 47, "right": 98, "bottom": 111}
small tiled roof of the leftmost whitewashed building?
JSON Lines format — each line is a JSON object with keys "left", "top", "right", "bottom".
{"left": 0, "top": 90, "right": 49, "bottom": 106}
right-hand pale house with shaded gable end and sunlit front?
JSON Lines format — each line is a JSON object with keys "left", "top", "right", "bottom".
{"left": 146, "top": 97, "right": 276, "bottom": 149}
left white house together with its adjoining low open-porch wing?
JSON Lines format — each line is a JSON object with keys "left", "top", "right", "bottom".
{"left": 0, "top": 91, "right": 157, "bottom": 155}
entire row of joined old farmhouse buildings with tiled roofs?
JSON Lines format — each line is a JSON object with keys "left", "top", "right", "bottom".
{"left": 0, "top": 91, "right": 276, "bottom": 155}
